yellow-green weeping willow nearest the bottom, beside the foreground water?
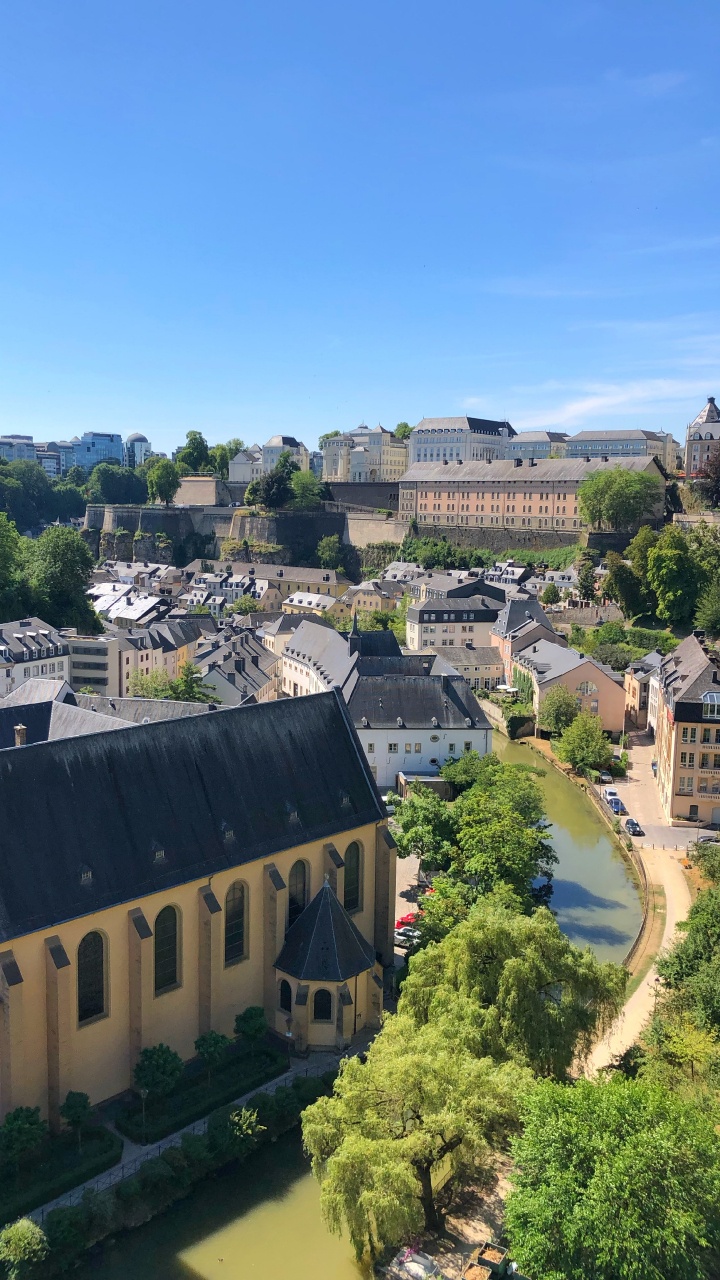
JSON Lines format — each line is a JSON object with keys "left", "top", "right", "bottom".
{"left": 302, "top": 1015, "right": 530, "bottom": 1257}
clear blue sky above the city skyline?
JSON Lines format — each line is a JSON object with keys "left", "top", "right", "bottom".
{"left": 0, "top": 0, "right": 720, "bottom": 449}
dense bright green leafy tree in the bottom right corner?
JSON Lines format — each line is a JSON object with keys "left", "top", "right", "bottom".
{"left": 506, "top": 1079, "right": 720, "bottom": 1280}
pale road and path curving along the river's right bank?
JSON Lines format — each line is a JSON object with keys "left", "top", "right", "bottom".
{"left": 585, "top": 735, "right": 697, "bottom": 1075}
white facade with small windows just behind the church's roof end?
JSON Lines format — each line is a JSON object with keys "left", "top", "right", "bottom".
{"left": 356, "top": 726, "right": 492, "bottom": 787}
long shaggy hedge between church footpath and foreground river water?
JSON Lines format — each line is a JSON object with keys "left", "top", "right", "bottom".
{"left": 23, "top": 1071, "right": 334, "bottom": 1280}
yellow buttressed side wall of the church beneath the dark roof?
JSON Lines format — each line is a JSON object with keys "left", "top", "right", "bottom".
{"left": 0, "top": 824, "right": 375, "bottom": 1115}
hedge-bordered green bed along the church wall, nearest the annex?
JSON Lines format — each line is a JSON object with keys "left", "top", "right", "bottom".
{"left": 115, "top": 1050, "right": 287, "bottom": 1143}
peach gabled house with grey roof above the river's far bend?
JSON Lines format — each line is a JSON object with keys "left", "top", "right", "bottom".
{"left": 512, "top": 640, "right": 625, "bottom": 733}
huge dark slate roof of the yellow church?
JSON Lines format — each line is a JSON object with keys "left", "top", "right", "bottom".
{"left": 0, "top": 691, "right": 384, "bottom": 941}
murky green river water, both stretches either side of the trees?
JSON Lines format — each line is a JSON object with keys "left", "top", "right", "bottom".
{"left": 85, "top": 733, "right": 641, "bottom": 1280}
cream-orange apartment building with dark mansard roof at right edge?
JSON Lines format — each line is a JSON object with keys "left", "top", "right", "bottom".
{"left": 651, "top": 631, "right": 720, "bottom": 824}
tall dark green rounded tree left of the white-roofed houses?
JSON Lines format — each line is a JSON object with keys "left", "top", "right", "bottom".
{"left": 24, "top": 526, "right": 102, "bottom": 635}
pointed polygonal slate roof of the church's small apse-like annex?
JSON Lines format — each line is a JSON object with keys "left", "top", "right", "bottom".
{"left": 275, "top": 881, "right": 375, "bottom": 982}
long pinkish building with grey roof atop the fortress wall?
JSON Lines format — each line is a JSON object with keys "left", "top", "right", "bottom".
{"left": 398, "top": 457, "right": 662, "bottom": 532}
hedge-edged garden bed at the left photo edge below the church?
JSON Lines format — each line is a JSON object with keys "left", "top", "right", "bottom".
{"left": 0, "top": 1125, "right": 123, "bottom": 1226}
